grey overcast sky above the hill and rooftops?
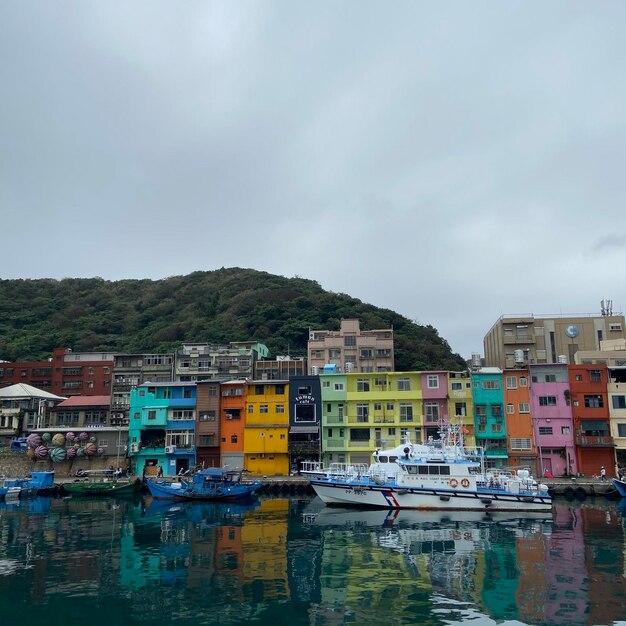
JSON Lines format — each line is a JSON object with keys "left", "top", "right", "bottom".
{"left": 0, "top": 0, "right": 626, "bottom": 357}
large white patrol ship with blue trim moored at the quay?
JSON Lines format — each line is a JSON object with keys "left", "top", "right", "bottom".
{"left": 302, "top": 426, "right": 552, "bottom": 511}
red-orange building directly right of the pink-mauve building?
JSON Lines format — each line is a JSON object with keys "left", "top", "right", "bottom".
{"left": 568, "top": 363, "right": 615, "bottom": 476}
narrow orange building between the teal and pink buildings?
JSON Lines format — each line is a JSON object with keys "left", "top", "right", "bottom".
{"left": 503, "top": 367, "right": 532, "bottom": 472}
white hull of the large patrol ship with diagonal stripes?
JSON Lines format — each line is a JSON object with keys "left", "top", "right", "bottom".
{"left": 311, "top": 480, "right": 552, "bottom": 511}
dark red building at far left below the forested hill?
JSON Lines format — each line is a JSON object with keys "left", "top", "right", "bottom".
{"left": 0, "top": 348, "right": 113, "bottom": 397}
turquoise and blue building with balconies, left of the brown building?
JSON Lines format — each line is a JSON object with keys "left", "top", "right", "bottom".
{"left": 128, "top": 382, "right": 196, "bottom": 476}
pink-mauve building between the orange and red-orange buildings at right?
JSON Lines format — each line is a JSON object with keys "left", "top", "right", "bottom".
{"left": 529, "top": 363, "right": 576, "bottom": 476}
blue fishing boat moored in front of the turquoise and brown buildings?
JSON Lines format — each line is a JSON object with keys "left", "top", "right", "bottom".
{"left": 146, "top": 468, "right": 263, "bottom": 501}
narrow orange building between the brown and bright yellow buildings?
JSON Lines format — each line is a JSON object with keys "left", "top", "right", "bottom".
{"left": 219, "top": 379, "right": 248, "bottom": 469}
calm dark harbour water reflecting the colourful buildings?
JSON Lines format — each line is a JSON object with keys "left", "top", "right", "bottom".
{"left": 0, "top": 497, "right": 626, "bottom": 626}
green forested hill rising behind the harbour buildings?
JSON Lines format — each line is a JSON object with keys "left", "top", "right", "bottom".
{"left": 0, "top": 268, "right": 465, "bottom": 371}
